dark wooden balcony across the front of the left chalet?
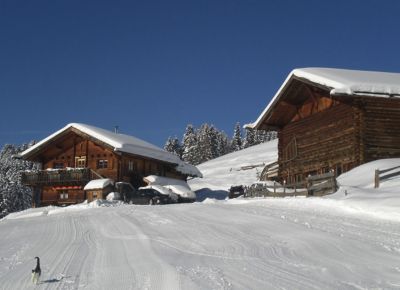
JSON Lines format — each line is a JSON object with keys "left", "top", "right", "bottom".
{"left": 21, "top": 168, "right": 98, "bottom": 186}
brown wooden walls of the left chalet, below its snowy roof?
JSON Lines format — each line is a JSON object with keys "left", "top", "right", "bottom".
{"left": 22, "top": 127, "right": 191, "bottom": 207}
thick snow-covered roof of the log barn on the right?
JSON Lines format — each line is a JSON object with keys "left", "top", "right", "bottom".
{"left": 245, "top": 67, "right": 400, "bottom": 128}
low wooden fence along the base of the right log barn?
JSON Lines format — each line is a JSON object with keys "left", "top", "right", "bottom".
{"left": 244, "top": 172, "right": 337, "bottom": 197}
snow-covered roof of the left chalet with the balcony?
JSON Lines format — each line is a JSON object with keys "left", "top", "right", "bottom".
{"left": 20, "top": 123, "right": 202, "bottom": 177}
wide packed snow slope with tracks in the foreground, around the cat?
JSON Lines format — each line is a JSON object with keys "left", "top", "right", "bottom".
{"left": 0, "top": 198, "right": 400, "bottom": 289}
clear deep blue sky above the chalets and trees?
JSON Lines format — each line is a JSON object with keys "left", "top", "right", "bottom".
{"left": 0, "top": 0, "right": 400, "bottom": 146}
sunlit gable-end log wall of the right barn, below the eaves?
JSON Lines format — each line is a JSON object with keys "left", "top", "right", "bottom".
{"left": 278, "top": 103, "right": 362, "bottom": 182}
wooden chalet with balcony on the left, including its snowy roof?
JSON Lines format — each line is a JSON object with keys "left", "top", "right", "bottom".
{"left": 20, "top": 123, "right": 202, "bottom": 207}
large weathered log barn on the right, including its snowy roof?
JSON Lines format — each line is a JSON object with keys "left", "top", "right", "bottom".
{"left": 246, "top": 68, "right": 400, "bottom": 184}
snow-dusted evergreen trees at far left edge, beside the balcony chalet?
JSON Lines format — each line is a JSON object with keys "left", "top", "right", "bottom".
{"left": 0, "top": 143, "right": 38, "bottom": 218}
